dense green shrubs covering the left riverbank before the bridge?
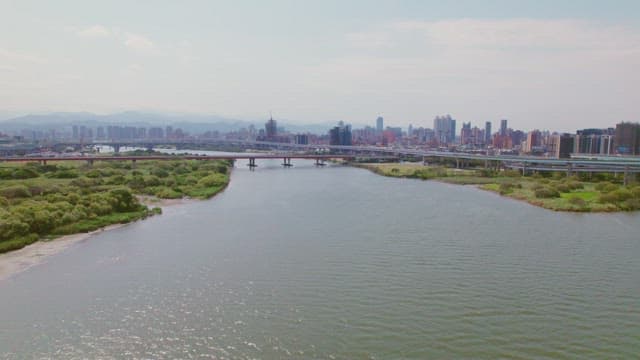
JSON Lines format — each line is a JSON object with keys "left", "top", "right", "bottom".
{"left": 0, "top": 154, "right": 232, "bottom": 253}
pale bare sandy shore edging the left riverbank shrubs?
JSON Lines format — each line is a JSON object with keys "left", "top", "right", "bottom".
{"left": 0, "top": 196, "right": 198, "bottom": 281}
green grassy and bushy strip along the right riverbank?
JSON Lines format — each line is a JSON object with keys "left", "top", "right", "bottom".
{"left": 352, "top": 163, "right": 640, "bottom": 212}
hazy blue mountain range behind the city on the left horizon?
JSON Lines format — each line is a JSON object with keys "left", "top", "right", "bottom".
{"left": 0, "top": 111, "right": 334, "bottom": 134}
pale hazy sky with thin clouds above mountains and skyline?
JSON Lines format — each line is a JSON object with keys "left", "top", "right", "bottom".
{"left": 0, "top": 0, "right": 640, "bottom": 131}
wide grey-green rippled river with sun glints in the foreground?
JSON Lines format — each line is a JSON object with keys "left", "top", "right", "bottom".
{"left": 0, "top": 160, "right": 640, "bottom": 359}
